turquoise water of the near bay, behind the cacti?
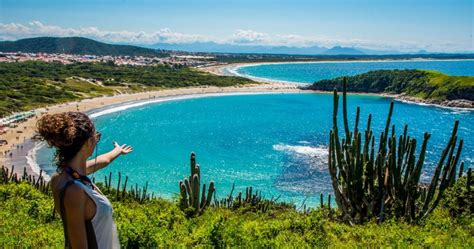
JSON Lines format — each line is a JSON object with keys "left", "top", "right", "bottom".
{"left": 37, "top": 59, "right": 474, "bottom": 205}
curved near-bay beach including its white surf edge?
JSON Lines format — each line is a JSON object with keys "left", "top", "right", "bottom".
{"left": 0, "top": 83, "right": 304, "bottom": 181}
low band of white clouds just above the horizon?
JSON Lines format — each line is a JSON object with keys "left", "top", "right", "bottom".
{"left": 0, "top": 21, "right": 472, "bottom": 52}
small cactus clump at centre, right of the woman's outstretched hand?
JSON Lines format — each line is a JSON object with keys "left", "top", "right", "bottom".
{"left": 179, "top": 152, "right": 215, "bottom": 215}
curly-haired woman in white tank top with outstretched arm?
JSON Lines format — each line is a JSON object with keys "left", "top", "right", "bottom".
{"left": 36, "top": 112, "right": 133, "bottom": 248}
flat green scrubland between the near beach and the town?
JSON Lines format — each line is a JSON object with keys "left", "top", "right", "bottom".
{"left": 0, "top": 61, "right": 255, "bottom": 117}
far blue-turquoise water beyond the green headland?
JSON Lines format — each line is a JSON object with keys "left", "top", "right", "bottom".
{"left": 237, "top": 60, "right": 474, "bottom": 83}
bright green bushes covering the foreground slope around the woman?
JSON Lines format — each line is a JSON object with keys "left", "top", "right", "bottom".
{"left": 0, "top": 167, "right": 474, "bottom": 248}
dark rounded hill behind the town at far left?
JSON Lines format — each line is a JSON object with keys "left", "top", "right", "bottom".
{"left": 0, "top": 37, "right": 165, "bottom": 57}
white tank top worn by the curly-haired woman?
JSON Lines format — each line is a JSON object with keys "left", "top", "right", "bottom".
{"left": 75, "top": 180, "right": 120, "bottom": 249}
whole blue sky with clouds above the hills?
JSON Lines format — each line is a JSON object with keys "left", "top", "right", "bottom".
{"left": 0, "top": 0, "right": 474, "bottom": 51}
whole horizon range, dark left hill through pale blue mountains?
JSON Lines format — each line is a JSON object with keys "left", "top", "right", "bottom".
{"left": 0, "top": 37, "right": 452, "bottom": 57}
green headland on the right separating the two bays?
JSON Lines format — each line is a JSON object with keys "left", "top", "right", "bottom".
{"left": 308, "top": 69, "right": 474, "bottom": 101}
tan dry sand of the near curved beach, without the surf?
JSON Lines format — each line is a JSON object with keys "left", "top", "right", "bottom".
{"left": 0, "top": 83, "right": 303, "bottom": 180}
